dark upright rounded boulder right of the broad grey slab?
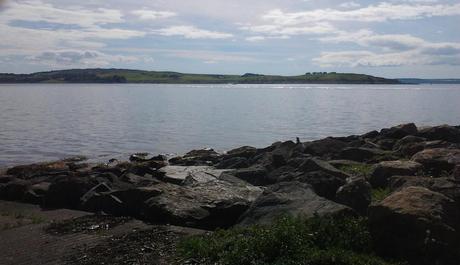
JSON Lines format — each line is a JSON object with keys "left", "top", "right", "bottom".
{"left": 335, "top": 178, "right": 372, "bottom": 215}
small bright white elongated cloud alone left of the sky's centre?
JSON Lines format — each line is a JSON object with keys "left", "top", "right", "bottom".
{"left": 152, "top": 26, "right": 233, "bottom": 39}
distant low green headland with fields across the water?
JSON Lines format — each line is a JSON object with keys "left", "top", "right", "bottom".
{"left": 0, "top": 69, "right": 399, "bottom": 84}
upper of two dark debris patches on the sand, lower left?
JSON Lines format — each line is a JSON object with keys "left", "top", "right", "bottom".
{"left": 45, "top": 215, "right": 132, "bottom": 235}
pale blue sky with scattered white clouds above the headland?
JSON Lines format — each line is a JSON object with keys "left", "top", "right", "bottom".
{"left": 0, "top": 0, "right": 460, "bottom": 78}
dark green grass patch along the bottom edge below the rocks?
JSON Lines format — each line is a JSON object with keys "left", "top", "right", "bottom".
{"left": 178, "top": 214, "right": 401, "bottom": 265}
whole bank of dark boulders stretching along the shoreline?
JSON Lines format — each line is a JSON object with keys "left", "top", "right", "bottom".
{"left": 0, "top": 124, "right": 460, "bottom": 264}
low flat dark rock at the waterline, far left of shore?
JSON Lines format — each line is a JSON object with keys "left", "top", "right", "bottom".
{"left": 6, "top": 161, "right": 69, "bottom": 179}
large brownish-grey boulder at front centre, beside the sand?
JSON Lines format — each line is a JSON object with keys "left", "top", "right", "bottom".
{"left": 142, "top": 180, "right": 261, "bottom": 229}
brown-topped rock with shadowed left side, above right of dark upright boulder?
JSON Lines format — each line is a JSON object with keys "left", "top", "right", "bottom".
{"left": 369, "top": 160, "right": 423, "bottom": 188}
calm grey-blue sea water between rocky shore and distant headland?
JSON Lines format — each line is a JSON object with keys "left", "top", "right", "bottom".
{"left": 0, "top": 84, "right": 460, "bottom": 166}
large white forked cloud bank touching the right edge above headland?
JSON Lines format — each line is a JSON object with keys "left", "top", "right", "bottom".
{"left": 313, "top": 27, "right": 460, "bottom": 67}
